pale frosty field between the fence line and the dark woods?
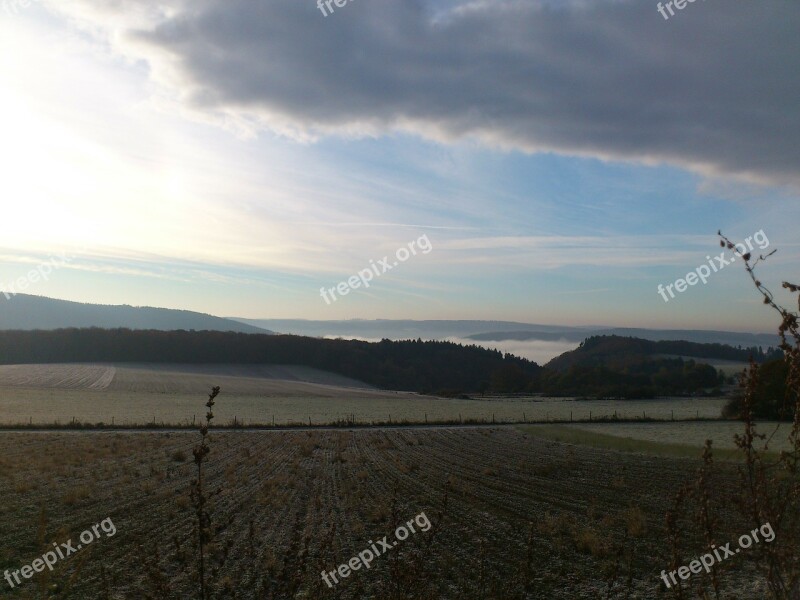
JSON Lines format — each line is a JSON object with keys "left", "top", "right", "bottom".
{"left": 0, "top": 364, "right": 724, "bottom": 425}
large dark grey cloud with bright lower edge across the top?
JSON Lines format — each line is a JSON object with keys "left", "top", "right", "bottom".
{"left": 45, "top": 0, "right": 800, "bottom": 186}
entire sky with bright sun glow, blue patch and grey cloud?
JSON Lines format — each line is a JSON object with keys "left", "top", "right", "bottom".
{"left": 0, "top": 0, "right": 800, "bottom": 331}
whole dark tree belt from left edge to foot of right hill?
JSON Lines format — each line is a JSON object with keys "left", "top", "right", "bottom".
{"left": 0, "top": 328, "right": 756, "bottom": 398}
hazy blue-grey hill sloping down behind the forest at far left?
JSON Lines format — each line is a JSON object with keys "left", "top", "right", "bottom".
{"left": 0, "top": 294, "right": 272, "bottom": 333}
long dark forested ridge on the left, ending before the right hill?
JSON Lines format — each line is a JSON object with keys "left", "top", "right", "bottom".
{"left": 0, "top": 328, "right": 542, "bottom": 393}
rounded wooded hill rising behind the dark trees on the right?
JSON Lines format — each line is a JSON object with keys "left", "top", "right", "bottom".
{"left": 546, "top": 335, "right": 783, "bottom": 371}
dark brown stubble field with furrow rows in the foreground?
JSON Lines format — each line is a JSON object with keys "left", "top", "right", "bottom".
{"left": 0, "top": 427, "right": 763, "bottom": 600}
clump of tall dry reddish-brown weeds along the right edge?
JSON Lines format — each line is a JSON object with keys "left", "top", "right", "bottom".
{"left": 667, "top": 233, "right": 800, "bottom": 600}
